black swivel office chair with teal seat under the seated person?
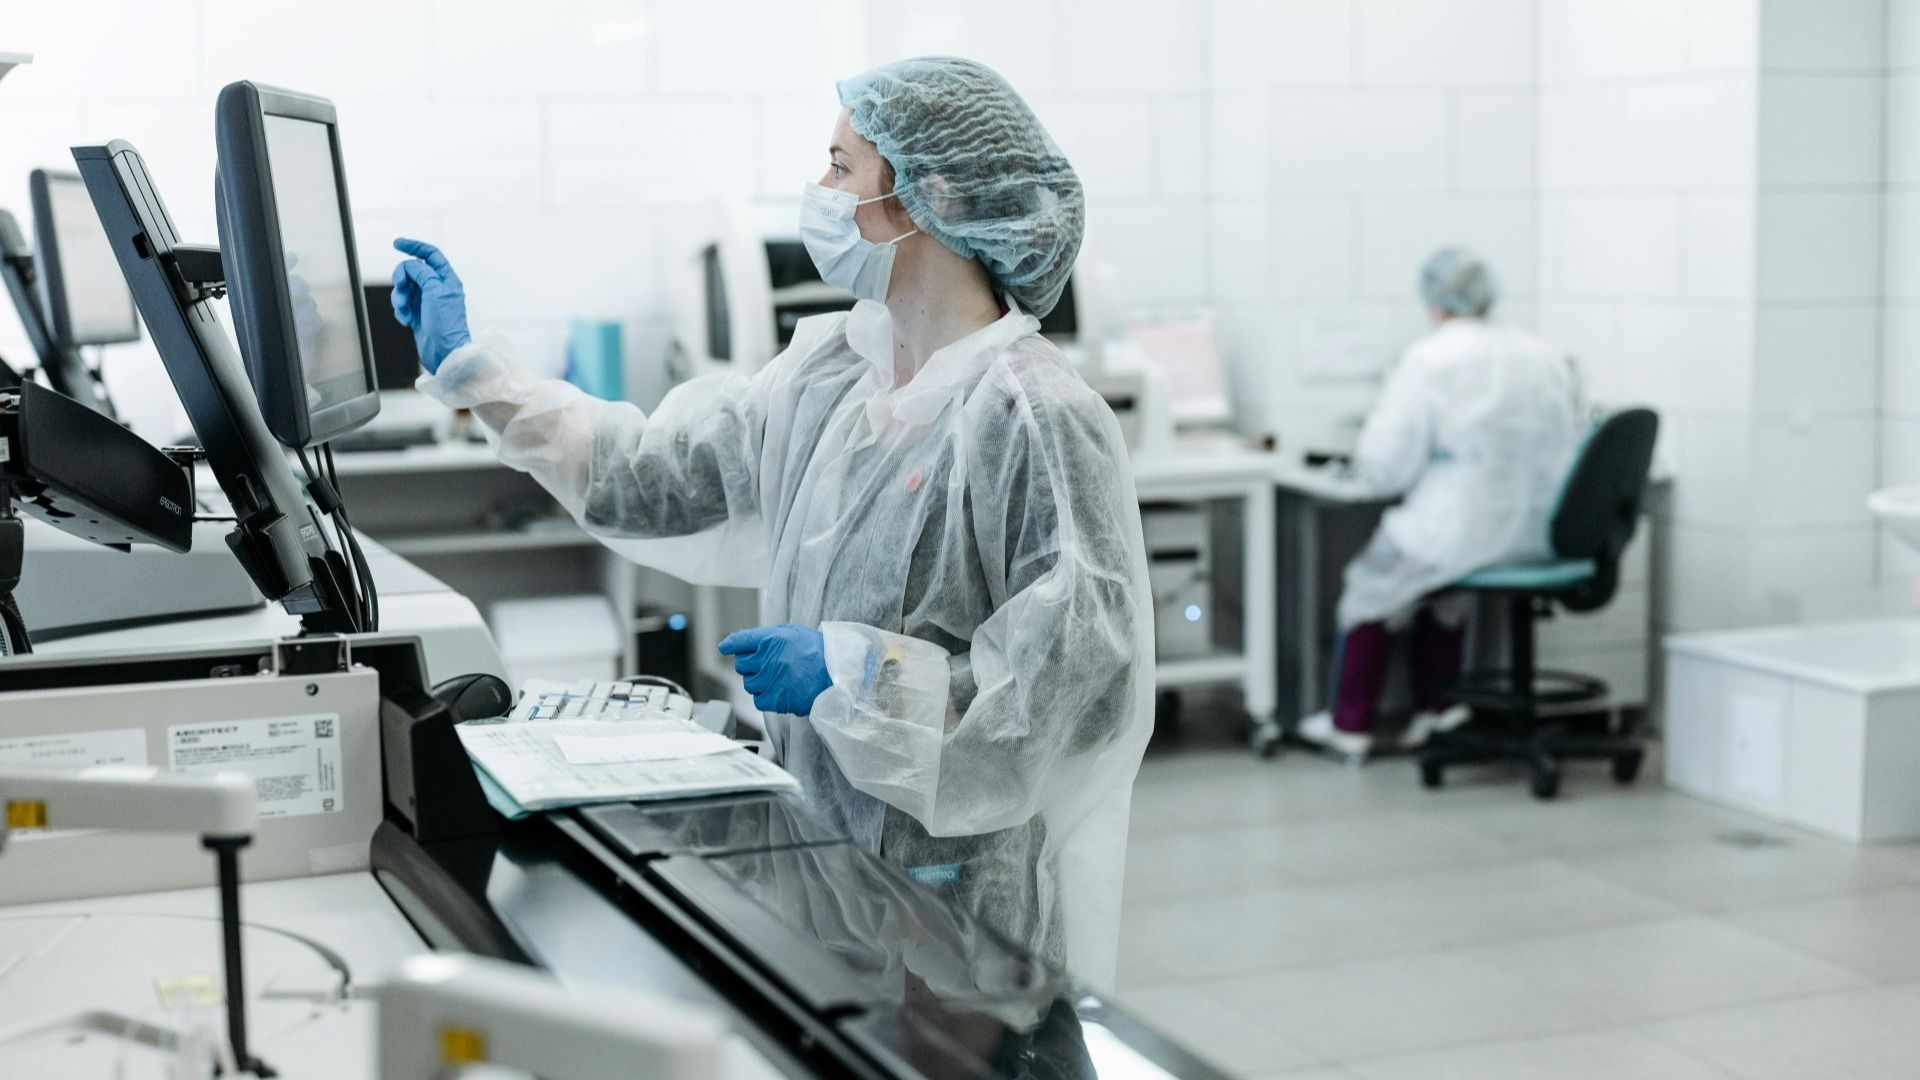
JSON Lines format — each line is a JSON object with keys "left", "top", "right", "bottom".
{"left": 1421, "top": 409, "right": 1661, "bottom": 799}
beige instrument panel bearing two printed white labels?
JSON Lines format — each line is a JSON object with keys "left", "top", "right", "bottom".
{"left": 0, "top": 632, "right": 382, "bottom": 903}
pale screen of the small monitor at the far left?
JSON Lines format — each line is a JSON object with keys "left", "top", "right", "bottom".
{"left": 35, "top": 173, "right": 140, "bottom": 346}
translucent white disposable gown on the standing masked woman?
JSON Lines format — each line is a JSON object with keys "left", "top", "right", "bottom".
{"left": 420, "top": 302, "right": 1154, "bottom": 986}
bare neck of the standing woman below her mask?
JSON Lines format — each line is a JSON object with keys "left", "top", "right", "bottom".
{"left": 887, "top": 234, "right": 1000, "bottom": 386}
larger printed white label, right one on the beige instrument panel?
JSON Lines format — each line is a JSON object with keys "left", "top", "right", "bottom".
{"left": 167, "top": 713, "right": 346, "bottom": 819}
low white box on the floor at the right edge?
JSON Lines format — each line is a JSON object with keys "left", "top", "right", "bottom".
{"left": 1667, "top": 619, "right": 1920, "bottom": 842}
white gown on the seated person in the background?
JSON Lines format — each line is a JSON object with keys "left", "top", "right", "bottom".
{"left": 1340, "top": 319, "right": 1588, "bottom": 628}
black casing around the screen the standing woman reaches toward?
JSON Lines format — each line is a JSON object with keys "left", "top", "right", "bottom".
{"left": 213, "top": 81, "right": 380, "bottom": 448}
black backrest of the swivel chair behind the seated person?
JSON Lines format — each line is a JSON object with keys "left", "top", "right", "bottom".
{"left": 1548, "top": 409, "right": 1661, "bottom": 611}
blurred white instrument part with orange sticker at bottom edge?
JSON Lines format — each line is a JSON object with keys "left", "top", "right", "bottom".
{"left": 376, "top": 955, "right": 728, "bottom": 1080}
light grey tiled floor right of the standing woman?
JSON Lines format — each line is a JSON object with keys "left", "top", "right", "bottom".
{"left": 1119, "top": 723, "right": 1920, "bottom": 1080}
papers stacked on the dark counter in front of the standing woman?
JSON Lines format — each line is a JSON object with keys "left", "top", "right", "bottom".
{"left": 455, "top": 691, "right": 799, "bottom": 817}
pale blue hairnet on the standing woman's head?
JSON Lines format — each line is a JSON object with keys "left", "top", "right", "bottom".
{"left": 839, "top": 56, "right": 1087, "bottom": 315}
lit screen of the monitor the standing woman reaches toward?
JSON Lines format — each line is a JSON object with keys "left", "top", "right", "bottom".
{"left": 265, "top": 113, "right": 372, "bottom": 413}
